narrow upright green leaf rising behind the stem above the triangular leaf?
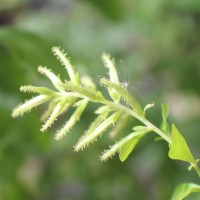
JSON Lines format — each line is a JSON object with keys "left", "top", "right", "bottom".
{"left": 160, "top": 104, "right": 170, "bottom": 135}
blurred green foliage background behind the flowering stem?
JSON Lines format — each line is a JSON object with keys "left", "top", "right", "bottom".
{"left": 0, "top": 0, "right": 200, "bottom": 200}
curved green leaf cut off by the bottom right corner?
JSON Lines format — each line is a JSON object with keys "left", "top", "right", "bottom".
{"left": 171, "top": 183, "right": 200, "bottom": 200}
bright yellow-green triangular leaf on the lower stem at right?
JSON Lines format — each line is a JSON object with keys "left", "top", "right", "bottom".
{"left": 168, "top": 124, "right": 200, "bottom": 176}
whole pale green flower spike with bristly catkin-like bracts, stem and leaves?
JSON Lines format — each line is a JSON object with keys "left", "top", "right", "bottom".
{"left": 12, "top": 47, "right": 200, "bottom": 175}
